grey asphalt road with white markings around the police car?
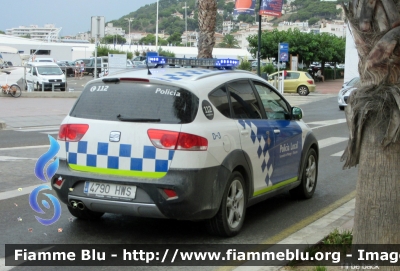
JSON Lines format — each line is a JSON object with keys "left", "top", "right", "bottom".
{"left": 0, "top": 96, "right": 357, "bottom": 270}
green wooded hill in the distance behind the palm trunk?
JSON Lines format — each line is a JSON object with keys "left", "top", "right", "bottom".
{"left": 110, "top": 0, "right": 340, "bottom": 35}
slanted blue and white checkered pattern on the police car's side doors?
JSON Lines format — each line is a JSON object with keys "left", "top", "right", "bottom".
{"left": 239, "top": 120, "right": 274, "bottom": 185}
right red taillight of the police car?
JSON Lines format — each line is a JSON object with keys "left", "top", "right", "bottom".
{"left": 147, "top": 129, "right": 208, "bottom": 151}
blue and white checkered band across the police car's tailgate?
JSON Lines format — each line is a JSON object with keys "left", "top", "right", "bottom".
{"left": 66, "top": 141, "right": 174, "bottom": 172}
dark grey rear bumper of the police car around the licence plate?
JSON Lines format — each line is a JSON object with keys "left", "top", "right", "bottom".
{"left": 51, "top": 160, "right": 228, "bottom": 220}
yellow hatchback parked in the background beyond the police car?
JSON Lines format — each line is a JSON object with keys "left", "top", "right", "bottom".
{"left": 268, "top": 71, "right": 315, "bottom": 96}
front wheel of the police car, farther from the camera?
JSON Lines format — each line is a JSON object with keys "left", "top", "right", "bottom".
{"left": 290, "top": 149, "right": 318, "bottom": 199}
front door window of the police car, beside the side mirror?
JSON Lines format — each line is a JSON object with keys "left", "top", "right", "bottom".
{"left": 254, "top": 81, "right": 290, "bottom": 120}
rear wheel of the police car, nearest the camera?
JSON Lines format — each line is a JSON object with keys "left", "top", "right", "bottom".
{"left": 206, "top": 171, "right": 247, "bottom": 237}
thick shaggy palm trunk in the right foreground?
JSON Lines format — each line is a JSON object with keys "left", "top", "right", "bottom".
{"left": 342, "top": 0, "right": 400, "bottom": 260}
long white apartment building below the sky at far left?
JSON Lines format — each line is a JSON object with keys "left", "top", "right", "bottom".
{"left": 6, "top": 24, "right": 61, "bottom": 40}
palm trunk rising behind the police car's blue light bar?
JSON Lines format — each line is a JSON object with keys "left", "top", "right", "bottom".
{"left": 197, "top": 0, "right": 217, "bottom": 58}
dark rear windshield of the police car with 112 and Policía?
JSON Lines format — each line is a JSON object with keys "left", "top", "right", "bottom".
{"left": 70, "top": 82, "right": 199, "bottom": 124}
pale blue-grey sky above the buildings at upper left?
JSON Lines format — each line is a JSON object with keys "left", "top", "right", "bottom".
{"left": 0, "top": 0, "right": 157, "bottom": 37}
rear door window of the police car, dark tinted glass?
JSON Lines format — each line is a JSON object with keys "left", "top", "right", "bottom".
{"left": 227, "top": 80, "right": 262, "bottom": 119}
